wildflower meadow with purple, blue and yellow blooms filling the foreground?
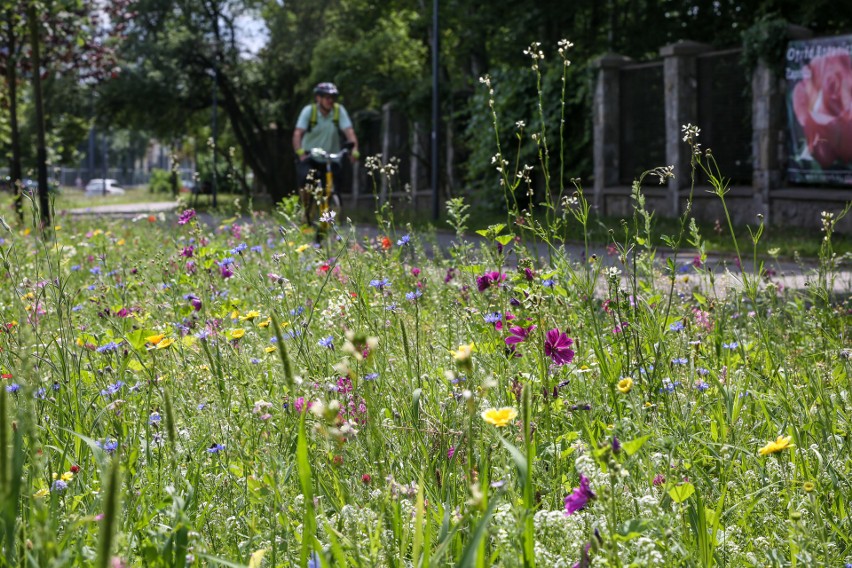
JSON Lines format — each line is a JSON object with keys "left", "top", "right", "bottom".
{"left": 0, "top": 44, "right": 852, "bottom": 567}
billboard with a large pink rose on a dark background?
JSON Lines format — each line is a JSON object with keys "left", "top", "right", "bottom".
{"left": 786, "top": 35, "right": 852, "bottom": 186}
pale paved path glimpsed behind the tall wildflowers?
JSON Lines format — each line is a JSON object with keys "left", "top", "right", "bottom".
{"left": 68, "top": 201, "right": 852, "bottom": 296}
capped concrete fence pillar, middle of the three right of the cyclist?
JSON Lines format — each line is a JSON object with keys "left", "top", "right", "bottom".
{"left": 660, "top": 41, "right": 710, "bottom": 217}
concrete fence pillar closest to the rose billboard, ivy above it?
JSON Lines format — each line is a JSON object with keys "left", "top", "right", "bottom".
{"left": 751, "top": 25, "right": 813, "bottom": 225}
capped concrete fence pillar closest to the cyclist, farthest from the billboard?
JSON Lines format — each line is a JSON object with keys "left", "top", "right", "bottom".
{"left": 592, "top": 53, "right": 630, "bottom": 211}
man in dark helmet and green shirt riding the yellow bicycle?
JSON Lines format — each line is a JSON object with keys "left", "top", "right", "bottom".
{"left": 293, "top": 83, "right": 360, "bottom": 200}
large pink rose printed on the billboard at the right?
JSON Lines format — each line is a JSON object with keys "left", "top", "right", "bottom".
{"left": 793, "top": 52, "right": 852, "bottom": 168}
